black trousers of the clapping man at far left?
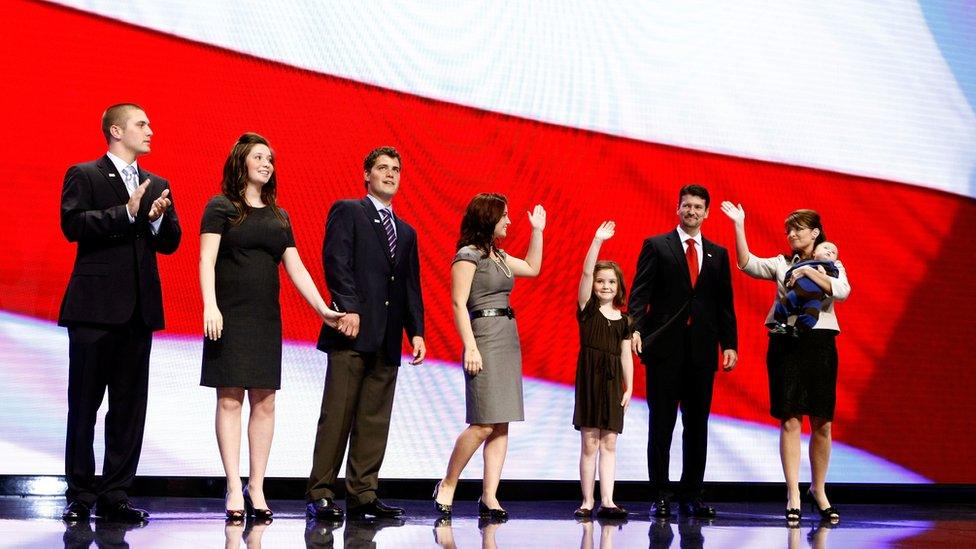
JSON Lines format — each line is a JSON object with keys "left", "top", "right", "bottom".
{"left": 64, "top": 321, "right": 152, "bottom": 506}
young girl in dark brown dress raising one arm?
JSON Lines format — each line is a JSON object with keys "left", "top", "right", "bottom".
{"left": 573, "top": 221, "right": 634, "bottom": 518}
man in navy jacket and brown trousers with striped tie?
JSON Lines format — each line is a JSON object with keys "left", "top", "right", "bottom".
{"left": 305, "top": 147, "right": 426, "bottom": 519}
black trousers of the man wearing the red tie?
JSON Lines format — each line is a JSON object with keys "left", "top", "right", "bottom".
{"left": 647, "top": 332, "right": 715, "bottom": 501}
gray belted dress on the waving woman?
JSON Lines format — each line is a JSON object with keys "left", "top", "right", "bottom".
{"left": 454, "top": 246, "right": 525, "bottom": 423}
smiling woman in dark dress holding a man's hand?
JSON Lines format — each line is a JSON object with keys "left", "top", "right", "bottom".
{"left": 200, "top": 133, "right": 342, "bottom": 520}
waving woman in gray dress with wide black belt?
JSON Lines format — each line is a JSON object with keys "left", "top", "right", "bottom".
{"left": 434, "top": 193, "right": 546, "bottom": 520}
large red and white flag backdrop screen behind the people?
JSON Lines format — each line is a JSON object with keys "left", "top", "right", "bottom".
{"left": 0, "top": 0, "right": 976, "bottom": 483}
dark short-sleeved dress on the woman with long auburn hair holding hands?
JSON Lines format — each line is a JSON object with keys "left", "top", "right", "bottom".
{"left": 200, "top": 195, "right": 295, "bottom": 389}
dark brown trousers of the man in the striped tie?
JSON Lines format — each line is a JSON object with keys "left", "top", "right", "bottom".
{"left": 305, "top": 350, "right": 397, "bottom": 507}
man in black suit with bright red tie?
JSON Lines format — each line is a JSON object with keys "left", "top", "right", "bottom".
{"left": 628, "top": 185, "right": 738, "bottom": 518}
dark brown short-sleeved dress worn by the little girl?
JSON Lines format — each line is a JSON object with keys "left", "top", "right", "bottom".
{"left": 573, "top": 298, "right": 631, "bottom": 433}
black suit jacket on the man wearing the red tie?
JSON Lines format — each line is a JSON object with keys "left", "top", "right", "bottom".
{"left": 628, "top": 230, "right": 738, "bottom": 370}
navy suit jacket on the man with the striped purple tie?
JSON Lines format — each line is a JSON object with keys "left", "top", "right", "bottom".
{"left": 318, "top": 198, "right": 424, "bottom": 365}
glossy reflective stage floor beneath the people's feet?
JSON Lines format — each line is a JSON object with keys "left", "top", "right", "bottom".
{"left": 0, "top": 496, "right": 976, "bottom": 549}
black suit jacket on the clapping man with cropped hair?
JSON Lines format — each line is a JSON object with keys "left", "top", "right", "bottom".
{"left": 58, "top": 156, "right": 182, "bottom": 330}
